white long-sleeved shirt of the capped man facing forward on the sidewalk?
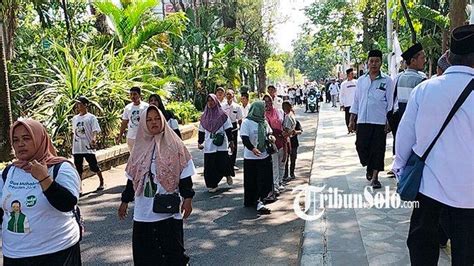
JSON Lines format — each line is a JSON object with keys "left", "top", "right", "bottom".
{"left": 350, "top": 73, "right": 393, "bottom": 125}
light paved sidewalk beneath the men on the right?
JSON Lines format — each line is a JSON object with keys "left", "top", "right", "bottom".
{"left": 300, "top": 104, "right": 450, "bottom": 265}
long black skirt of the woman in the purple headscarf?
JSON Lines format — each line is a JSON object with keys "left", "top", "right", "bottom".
{"left": 204, "top": 151, "right": 235, "bottom": 188}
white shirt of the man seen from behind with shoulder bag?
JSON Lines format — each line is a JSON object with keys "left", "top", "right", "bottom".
{"left": 393, "top": 66, "right": 474, "bottom": 209}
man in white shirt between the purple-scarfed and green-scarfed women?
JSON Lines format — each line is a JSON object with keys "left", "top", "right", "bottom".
{"left": 222, "top": 89, "right": 243, "bottom": 170}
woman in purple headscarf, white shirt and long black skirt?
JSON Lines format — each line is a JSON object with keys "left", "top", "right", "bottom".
{"left": 198, "top": 93, "right": 235, "bottom": 193}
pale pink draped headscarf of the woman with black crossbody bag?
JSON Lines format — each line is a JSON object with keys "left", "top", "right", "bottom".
{"left": 125, "top": 105, "right": 191, "bottom": 196}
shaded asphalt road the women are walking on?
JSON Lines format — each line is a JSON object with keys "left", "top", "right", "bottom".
{"left": 80, "top": 105, "right": 318, "bottom": 265}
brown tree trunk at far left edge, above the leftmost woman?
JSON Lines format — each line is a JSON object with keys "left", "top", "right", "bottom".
{"left": 0, "top": 22, "right": 12, "bottom": 162}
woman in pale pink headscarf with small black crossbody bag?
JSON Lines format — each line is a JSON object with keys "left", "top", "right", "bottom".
{"left": 118, "top": 105, "right": 195, "bottom": 265}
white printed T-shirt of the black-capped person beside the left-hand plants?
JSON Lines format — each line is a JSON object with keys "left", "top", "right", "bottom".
{"left": 72, "top": 113, "right": 100, "bottom": 154}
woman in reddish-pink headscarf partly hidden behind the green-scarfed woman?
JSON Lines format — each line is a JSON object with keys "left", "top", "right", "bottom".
{"left": 263, "top": 95, "right": 287, "bottom": 194}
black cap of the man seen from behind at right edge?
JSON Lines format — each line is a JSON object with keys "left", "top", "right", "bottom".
{"left": 449, "top": 24, "right": 474, "bottom": 55}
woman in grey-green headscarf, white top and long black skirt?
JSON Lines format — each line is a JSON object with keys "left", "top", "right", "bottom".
{"left": 240, "top": 101, "right": 273, "bottom": 215}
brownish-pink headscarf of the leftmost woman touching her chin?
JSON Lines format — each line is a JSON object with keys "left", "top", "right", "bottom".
{"left": 10, "top": 118, "right": 69, "bottom": 173}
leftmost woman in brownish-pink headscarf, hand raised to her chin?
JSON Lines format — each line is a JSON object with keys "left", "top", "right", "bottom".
{"left": 0, "top": 119, "right": 81, "bottom": 265}
